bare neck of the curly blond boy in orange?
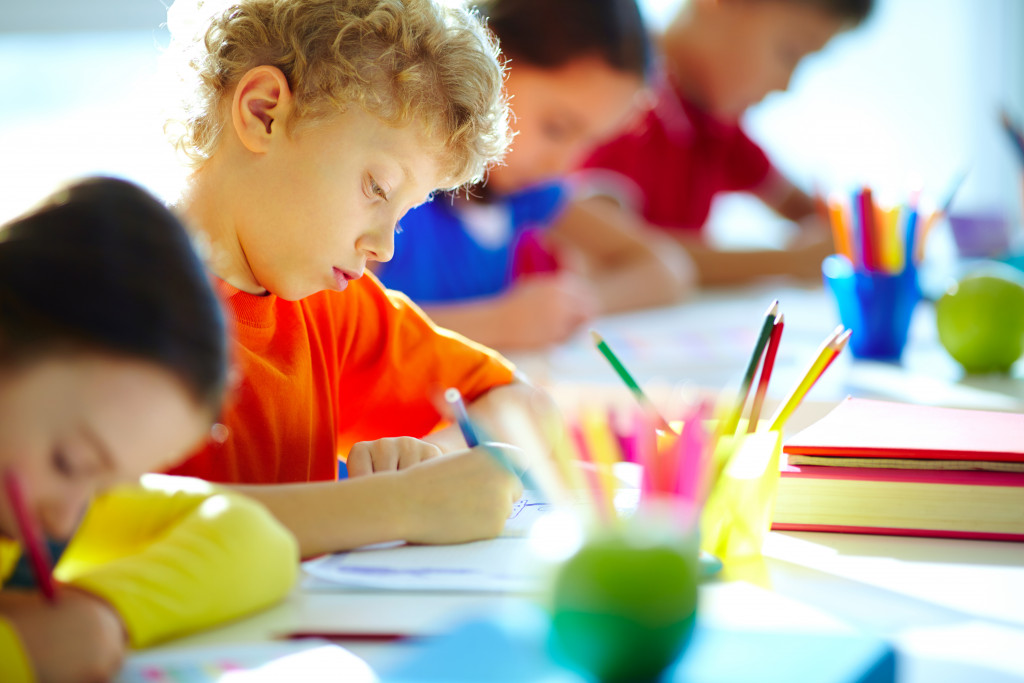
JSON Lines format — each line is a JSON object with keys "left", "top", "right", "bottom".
{"left": 176, "top": 164, "right": 267, "bottom": 295}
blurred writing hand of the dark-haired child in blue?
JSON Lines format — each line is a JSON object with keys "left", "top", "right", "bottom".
{"left": 501, "top": 271, "right": 599, "bottom": 348}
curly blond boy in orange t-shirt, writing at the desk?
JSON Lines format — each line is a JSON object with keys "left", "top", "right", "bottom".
{"left": 159, "top": 0, "right": 545, "bottom": 556}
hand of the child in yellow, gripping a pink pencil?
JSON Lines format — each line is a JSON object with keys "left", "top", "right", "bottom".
{"left": 2, "top": 586, "right": 125, "bottom": 683}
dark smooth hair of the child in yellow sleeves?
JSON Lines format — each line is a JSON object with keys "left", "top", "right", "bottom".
{"left": 0, "top": 178, "right": 227, "bottom": 413}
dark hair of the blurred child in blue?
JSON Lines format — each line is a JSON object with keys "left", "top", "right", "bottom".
{"left": 476, "top": 0, "right": 653, "bottom": 78}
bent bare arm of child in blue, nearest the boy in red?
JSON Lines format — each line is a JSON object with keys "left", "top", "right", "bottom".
{"left": 551, "top": 198, "right": 695, "bottom": 314}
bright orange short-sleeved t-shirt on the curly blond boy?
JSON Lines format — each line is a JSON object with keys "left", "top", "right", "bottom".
{"left": 171, "top": 274, "right": 514, "bottom": 483}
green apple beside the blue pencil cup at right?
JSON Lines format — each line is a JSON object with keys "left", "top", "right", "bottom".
{"left": 935, "top": 263, "right": 1024, "bottom": 373}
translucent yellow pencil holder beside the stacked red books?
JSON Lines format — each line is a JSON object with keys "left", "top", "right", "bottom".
{"left": 700, "top": 430, "right": 782, "bottom": 566}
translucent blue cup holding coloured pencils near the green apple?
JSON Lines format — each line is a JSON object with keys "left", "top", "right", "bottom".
{"left": 821, "top": 254, "right": 921, "bottom": 361}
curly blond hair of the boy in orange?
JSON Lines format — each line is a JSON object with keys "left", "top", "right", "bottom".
{"left": 165, "top": 0, "right": 510, "bottom": 187}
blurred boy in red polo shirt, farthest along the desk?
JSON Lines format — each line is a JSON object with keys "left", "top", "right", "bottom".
{"left": 587, "top": 0, "right": 872, "bottom": 285}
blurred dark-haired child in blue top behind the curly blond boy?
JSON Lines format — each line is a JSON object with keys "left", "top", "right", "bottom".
{"left": 378, "top": 0, "right": 691, "bottom": 349}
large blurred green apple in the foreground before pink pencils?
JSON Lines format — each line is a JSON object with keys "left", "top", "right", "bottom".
{"left": 552, "top": 523, "right": 698, "bottom": 681}
